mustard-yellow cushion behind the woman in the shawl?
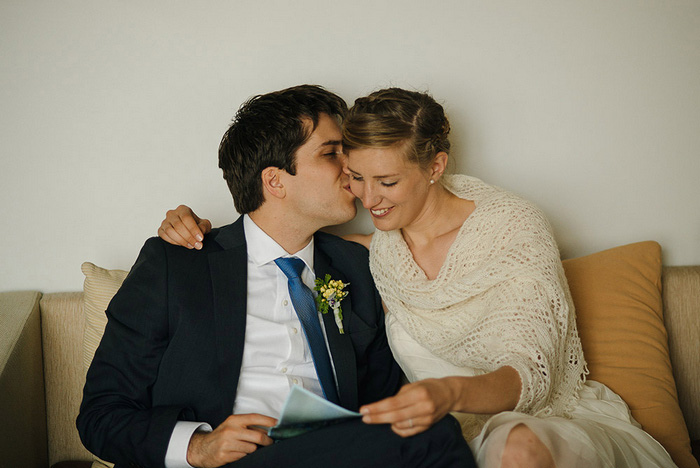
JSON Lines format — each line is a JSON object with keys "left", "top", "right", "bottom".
{"left": 564, "top": 241, "right": 698, "bottom": 468}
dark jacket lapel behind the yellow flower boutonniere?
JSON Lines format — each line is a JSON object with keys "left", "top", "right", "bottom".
{"left": 314, "top": 247, "right": 358, "bottom": 409}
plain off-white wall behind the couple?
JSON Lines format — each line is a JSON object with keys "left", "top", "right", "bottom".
{"left": 0, "top": 0, "right": 700, "bottom": 292}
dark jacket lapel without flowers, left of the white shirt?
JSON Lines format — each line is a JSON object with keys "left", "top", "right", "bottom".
{"left": 208, "top": 217, "right": 248, "bottom": 425}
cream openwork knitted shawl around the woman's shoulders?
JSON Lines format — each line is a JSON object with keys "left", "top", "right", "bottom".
{"left": 370, "top": 175, "right": 588, "bottom": 416}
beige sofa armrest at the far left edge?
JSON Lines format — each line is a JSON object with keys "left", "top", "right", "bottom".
{"left": 0, "top": 291, "right": 49, "bottom": 467}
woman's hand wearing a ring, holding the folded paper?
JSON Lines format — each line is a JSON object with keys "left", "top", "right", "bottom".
{"left": 360, "top": 379, "right": 459, "bottom": 437}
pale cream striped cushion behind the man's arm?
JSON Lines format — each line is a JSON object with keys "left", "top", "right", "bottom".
{"left": 80, "top": 262, "right": 128, "bottom": 468}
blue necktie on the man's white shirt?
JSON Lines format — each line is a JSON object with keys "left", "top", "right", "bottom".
{"left": 275, "top": 257, "right": 340, "bottom": 404}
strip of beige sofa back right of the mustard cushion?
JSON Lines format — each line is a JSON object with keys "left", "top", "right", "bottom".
{"left": 662, "top": 266, "right": 700, "bottom": 441}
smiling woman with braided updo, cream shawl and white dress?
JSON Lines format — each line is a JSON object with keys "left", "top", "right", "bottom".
{"left": 159, "top": 88, "right": 675, "bottom": 468}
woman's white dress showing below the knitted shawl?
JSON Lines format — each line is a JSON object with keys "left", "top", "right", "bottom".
{"left": 386, "top": 313, "right": 676, "bottom": 468}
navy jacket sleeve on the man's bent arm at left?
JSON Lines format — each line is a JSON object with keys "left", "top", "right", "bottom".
{"left": 77, "top": 238, "right": 188, "bottom": 467}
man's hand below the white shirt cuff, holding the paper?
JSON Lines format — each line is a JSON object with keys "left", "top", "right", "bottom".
{"left": 187, "top": 414, "right": 277, "bottom": 468}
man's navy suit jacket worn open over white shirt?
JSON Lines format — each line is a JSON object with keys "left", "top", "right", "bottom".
{"left": 77, "top": 218, "right": 400, "bottom": 467}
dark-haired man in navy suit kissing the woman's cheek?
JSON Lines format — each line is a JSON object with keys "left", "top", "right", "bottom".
{"left": 77, "top": 85, "right": 474, "bottom": 468}
